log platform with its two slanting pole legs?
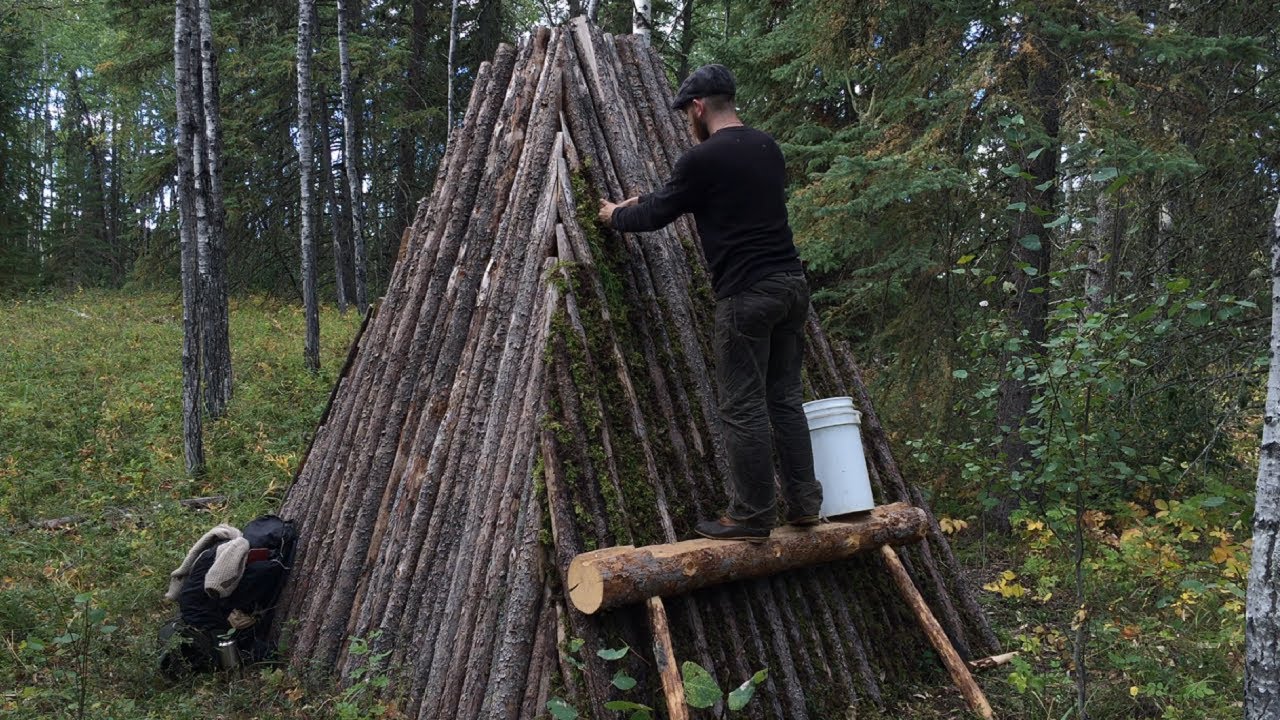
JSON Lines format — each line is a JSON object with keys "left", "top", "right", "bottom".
{"left": 568, "top": 502, "right": 995, "bottom": 720}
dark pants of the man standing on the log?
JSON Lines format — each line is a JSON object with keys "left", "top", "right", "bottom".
{"left": 716, "top": 272, "right": 822, "bottom": 527}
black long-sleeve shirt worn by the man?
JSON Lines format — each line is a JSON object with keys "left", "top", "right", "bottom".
{"left": 613, "top": 126, "right": 801, "bottom": 299}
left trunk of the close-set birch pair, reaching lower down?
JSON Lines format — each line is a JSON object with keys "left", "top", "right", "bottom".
{"left": 173, "top": 0, "right": 205, "bottom": 475}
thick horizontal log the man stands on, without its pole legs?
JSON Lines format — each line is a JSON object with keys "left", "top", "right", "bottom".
{"left": 568, "top": 502, "right": 928, "bottom": 615}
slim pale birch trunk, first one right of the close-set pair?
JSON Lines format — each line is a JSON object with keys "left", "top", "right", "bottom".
{"left": 298, "top": 0, "right": 320, "bottom": 373}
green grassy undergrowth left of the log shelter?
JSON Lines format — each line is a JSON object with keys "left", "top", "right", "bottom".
{"left": 0, "top": 292, "right": 360, "bottom": 719}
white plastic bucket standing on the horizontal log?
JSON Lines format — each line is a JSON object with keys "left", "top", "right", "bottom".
{"left": 804, "top": 397, "right": 876, "bottom": 518}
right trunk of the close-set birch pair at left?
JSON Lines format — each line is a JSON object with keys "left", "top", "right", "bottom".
{"left": 197, "top": 0, "right": 232, "bottom": 418}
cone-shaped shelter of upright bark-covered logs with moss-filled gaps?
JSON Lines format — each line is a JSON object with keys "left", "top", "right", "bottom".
{"left": 282, "top": 20, "right": 995, "bottom": 720}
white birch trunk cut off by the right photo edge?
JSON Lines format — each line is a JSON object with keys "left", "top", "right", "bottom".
{"left": 1244, "top": 197, "right": 1280, "bottom": 720}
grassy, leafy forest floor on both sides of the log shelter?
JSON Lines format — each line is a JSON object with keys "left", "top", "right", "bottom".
{"left": 0, "top": 292, "right": 1252, "bottom": 720}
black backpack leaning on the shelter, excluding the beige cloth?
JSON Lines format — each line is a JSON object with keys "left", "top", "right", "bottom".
{"left": 160, "top": 515, "right": 298, "bottom": 676}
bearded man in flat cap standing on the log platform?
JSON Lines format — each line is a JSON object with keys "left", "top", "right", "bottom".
{"left": 599, "top": 65, "right": 822, "bottom": 542}
